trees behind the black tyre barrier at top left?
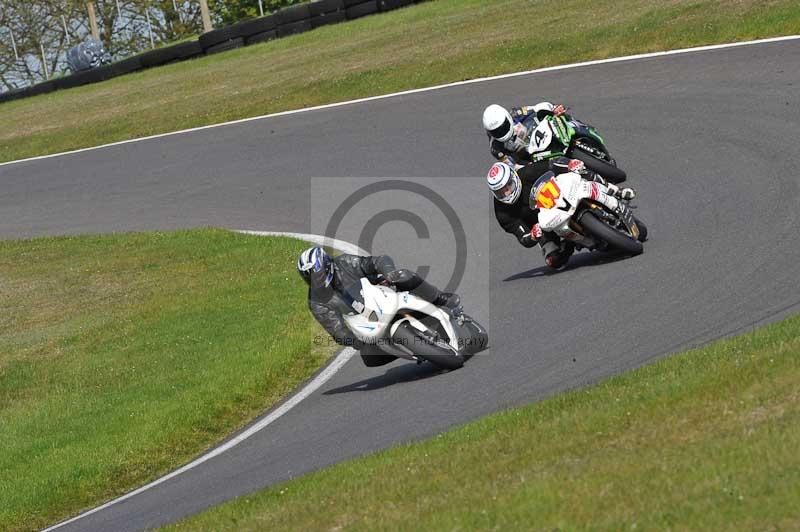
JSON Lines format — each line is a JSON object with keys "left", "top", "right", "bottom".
{"left": 0, "top": 0, "right": 304, "bottom": 91}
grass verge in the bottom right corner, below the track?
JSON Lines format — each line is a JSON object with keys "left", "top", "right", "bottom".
{"left": 170, "top": 315, "right": 800, "bottom": 530}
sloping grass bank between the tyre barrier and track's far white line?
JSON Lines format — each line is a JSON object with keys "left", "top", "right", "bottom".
{"left": 0, "top": 0, "right": 800, "bottom": 161}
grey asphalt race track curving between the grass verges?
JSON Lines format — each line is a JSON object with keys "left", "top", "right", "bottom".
{"left": 0, "top": 41, "right": 800, "bottom": 531}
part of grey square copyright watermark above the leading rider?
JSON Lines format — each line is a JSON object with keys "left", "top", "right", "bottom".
{"left": 311, "top": 178, "right": 476, "bottom": 292}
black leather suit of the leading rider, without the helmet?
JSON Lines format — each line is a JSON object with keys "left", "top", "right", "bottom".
{"left": 308, "top": 254, "right": 450, "bottom": 366}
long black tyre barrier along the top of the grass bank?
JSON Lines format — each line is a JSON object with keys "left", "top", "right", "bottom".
{"left": 0, "top": 0, "right": 423, "bottom": 103}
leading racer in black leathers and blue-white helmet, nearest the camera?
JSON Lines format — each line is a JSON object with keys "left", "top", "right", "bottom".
{"left": 297, "top": 246, "right": 461, "bottom": 367}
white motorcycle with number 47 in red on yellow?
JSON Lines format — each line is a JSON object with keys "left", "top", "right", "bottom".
{"left": 530, "top": 168, "right": 647, "bottom": 255}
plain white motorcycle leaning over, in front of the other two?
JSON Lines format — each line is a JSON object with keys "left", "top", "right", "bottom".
{"left": 342, "top": 278, "right": 489, "bottom": 370}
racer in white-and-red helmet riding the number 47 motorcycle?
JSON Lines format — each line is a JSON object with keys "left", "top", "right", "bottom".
{"left": 486, "top": 157, "right": 636, "bottom": 269}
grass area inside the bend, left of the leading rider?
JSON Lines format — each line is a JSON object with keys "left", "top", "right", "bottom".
{"left": 0, "top": 229, "right": 331, "bottom": 530}
